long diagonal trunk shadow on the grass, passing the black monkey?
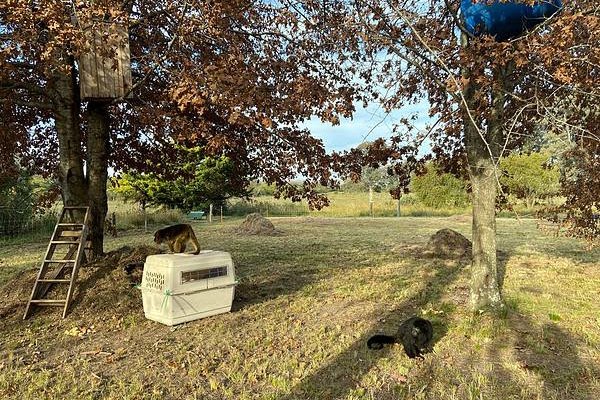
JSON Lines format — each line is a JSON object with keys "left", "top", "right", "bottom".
{"left": 278, "top": 260, "right": 466, "bottom": 400}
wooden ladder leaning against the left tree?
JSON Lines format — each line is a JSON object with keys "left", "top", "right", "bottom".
{"left": 23, "top": 206, "right": 89, "bottom": 319}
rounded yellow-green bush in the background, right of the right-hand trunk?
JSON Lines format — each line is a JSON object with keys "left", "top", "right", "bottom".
{"left": 500, "top": 153, "right": 560, "bottom": 208}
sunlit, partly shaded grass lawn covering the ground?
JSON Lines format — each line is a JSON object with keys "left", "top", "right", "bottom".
{"left": 0, "top": 216, "right": 600, "bottom": 400}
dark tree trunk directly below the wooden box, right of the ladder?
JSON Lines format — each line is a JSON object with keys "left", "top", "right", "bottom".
{"left": 87, "top": 101, "right": 110, "bottom": 257}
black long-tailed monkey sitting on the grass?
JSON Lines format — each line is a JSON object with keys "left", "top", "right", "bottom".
{"left": 367, "top": 317, "right": 433, "bottom": 358}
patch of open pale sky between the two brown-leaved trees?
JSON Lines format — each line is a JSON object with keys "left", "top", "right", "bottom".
{"left": 305, "top": 102, "right": 430, "bottom": 152}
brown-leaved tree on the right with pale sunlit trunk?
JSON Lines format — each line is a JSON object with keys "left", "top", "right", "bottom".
{"left": 332, "top": 0, "right": 600, "bottom": 310}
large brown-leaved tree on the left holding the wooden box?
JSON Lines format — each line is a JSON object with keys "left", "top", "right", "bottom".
{"left": 0, "top": 0, "right": 354, "bottom": 254}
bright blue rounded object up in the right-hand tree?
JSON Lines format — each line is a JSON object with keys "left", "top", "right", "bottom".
{"left": 460, "top": 0, "right": 562, "bottom": 41}
